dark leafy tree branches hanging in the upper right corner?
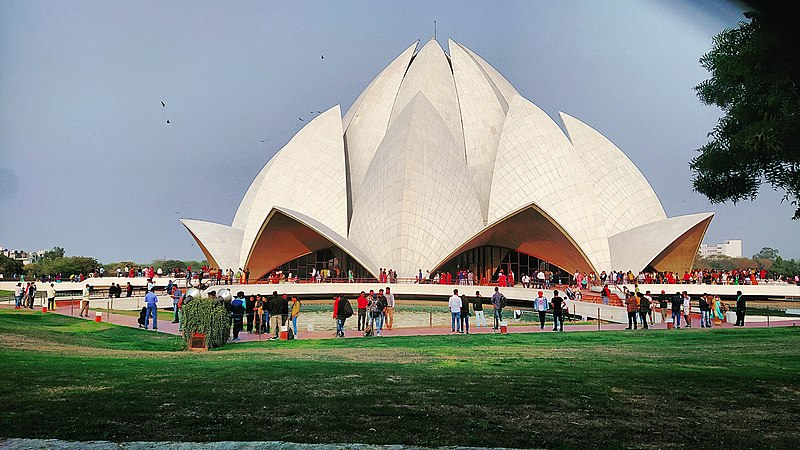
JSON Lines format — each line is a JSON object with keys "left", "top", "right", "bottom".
{"left": 690, "top": 2, "right": 800, "bottom": 219}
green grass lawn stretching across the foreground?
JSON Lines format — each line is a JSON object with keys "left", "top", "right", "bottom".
{"left": 0, "top": 309, "right": 800, "bottom": 448}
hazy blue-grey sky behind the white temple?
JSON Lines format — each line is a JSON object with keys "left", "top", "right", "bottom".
{"left": 0, "top": 0, "right": 800, "bottom": 262}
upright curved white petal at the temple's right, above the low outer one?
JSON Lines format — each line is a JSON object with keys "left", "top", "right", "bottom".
{"left": 559, "top": 112, "right": 667, "bottom": 236}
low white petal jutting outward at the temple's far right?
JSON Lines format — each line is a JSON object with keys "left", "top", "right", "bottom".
{"left": 608, "top": 213, "right": 714, "bottom": 273}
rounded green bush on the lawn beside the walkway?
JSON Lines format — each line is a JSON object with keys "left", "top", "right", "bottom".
{"left": 181, "top": 298, "right": 231, "bottom": 348}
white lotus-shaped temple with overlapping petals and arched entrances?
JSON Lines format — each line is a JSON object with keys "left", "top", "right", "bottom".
{"left": 181, "top": 40, "right": 713, "bottom": 280}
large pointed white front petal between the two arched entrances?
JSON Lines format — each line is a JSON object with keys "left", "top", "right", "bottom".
{"left": 350, "top": 93, "right": 483, "bottom": 277}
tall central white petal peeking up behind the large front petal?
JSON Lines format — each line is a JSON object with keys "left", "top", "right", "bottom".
{"left": 389, "top": 39, "right": 464, "bottom": 157}
